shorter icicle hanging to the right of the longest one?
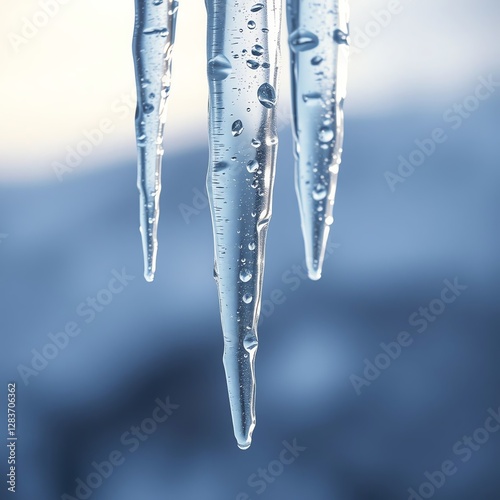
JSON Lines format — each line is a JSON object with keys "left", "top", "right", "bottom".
{"left": 287, "top": 0, "right": 349, "bottom": 280}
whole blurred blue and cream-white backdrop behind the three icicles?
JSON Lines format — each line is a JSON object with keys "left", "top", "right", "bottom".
{"left": 0, "top": 0, "right": 500, "bottom": 500}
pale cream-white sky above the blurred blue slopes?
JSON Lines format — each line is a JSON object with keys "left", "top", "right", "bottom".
{"left": 0, "top": 0, "right": 500, "bottom": 180}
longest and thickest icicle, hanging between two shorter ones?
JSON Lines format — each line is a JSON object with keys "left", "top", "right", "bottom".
{"left": 206, "top": 0, "right": 281, "bottom": 449}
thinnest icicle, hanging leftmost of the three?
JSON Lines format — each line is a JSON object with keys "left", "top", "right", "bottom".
{"left": 133, "top": 0, "right": 178, "bottom": 281}
